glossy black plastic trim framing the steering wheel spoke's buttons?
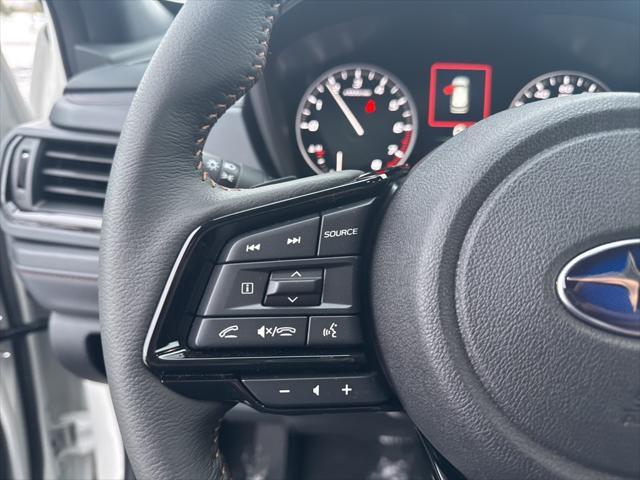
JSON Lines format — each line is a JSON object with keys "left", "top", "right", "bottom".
{"left": 143, "top": 169, "right": 404, "bottom": 414}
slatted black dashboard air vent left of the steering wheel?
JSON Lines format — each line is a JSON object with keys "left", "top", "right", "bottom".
{"left": 35, "top": 140, "right": 115, "bottom": 211}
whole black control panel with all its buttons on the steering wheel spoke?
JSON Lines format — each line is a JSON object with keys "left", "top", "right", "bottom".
{"left": 144, "top": 173, "right": 398, "bottom": 413}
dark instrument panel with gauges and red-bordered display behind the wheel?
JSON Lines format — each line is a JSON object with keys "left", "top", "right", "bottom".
{"left": 250, "top": 1, "right": 640, "bottom": 176}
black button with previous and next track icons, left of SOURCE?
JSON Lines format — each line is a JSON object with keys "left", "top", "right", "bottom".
{"left": 220, "top": 216, "right": 320, "bottom": 262}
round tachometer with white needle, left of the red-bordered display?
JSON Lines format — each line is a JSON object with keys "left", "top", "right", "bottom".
{"left": 296, "top": 65, "right": 418, "bottom": 173}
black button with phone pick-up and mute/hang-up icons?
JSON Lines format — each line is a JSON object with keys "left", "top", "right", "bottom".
{"left": 189, "top": 317, "right": 307, "bottom": 349}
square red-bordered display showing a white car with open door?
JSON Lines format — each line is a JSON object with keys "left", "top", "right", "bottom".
{"left": 427, "top": 63, "right": 492, "bottom": 128}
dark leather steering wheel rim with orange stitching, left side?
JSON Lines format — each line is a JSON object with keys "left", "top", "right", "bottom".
{"left": 99, "top": 0, "right": 357, "bottom": 480}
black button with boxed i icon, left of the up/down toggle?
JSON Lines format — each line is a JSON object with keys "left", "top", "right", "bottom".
{"left": 198, "top": 265, "right": 269, "bottom": 315}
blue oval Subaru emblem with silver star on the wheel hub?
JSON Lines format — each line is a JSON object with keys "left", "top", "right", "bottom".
{"left": 556, "top": 239, "right": 640, "bottom": 337}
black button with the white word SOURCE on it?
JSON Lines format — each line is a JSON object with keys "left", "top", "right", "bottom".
{"left": 318, "top": 199, "right": 374, "bottom": 257}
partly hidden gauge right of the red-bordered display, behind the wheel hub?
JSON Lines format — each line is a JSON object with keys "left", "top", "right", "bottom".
{"left": 511, "top": 71, "right": 609, "bottom": 107}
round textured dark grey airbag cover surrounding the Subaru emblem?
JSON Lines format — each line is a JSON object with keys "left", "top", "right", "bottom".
{"left": 372, "top": 94, "right": 640, "bottom": 479}
